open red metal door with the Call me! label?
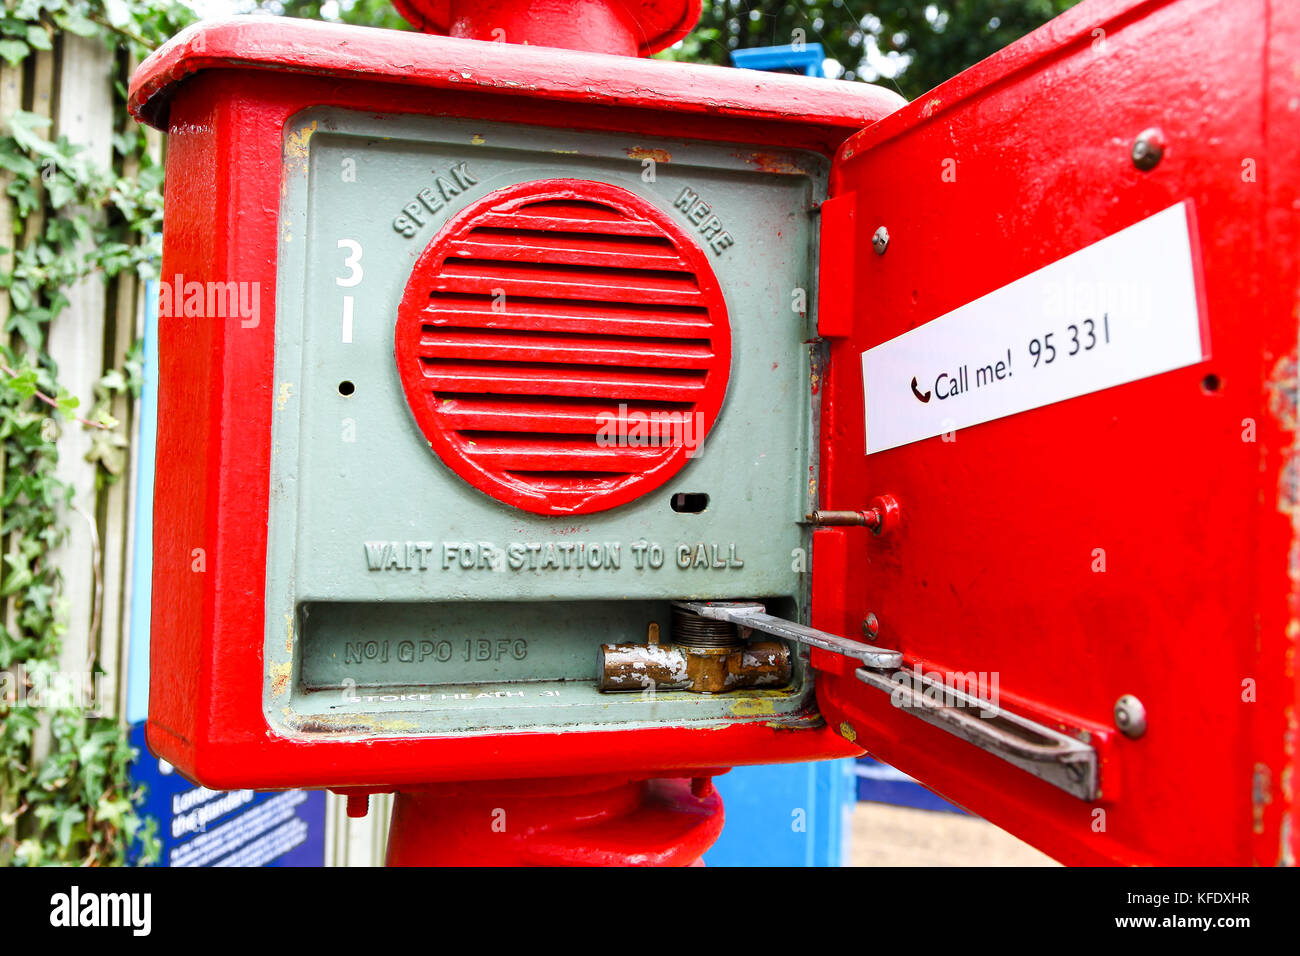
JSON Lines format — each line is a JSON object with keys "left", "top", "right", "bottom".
{"left": 813, "top": 0, "right": 1300, "bottom": 865}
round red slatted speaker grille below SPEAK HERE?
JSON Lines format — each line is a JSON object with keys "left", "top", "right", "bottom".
{"left": 397, "top": 179, "right": 731, "bottom": 514}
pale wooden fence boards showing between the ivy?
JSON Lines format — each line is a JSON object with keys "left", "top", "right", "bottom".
{"left": 0, "top": 34, "right": 148, "bottom": 756}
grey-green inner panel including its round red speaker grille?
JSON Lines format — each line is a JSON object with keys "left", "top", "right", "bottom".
{"left": 264, "top": 108, "right": 826, "bottom": 736}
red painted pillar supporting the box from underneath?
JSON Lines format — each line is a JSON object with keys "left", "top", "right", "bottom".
{"left": 387, "top": 778, "right": 723, "bottom": 866}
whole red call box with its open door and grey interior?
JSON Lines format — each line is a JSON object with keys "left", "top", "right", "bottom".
{"left": 130, "top": 0, "right": 1300, "bottom": 865}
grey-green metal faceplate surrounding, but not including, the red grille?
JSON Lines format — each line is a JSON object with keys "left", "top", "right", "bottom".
{"left": 265, "top": 108, "right": 828, "bottom": 734}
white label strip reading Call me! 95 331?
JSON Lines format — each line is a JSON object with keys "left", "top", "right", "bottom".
{"left": 862, "top": 203, "right": 1209, "bottom": 455}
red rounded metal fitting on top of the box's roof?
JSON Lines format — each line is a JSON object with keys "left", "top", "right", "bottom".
{"left": 393, "top": 0, "right": 701, "bottom": 56}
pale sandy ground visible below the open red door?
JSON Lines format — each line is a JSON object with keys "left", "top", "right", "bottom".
{"left": 852, "top": 803, "right": 1060, "bottom": 866}
